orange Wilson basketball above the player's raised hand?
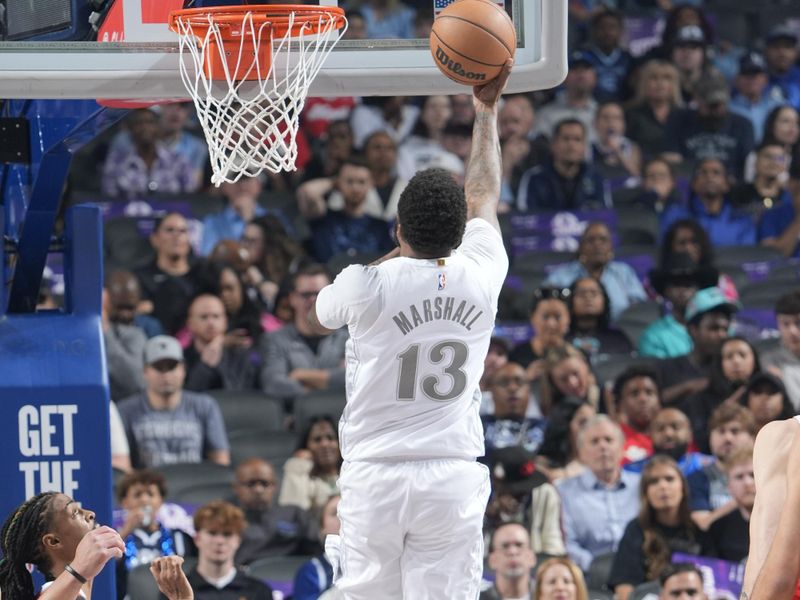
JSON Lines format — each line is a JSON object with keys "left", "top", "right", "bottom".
{"left": 430, "top": 0, "right": 517, "bottom": 86}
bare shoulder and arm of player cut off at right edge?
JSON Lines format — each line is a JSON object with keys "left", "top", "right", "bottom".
{"left": 741, "top": 416, "right": 800, "bottom": 600}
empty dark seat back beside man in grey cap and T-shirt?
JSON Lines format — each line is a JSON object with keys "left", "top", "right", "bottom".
{"left": 209, "top": 390, "right": 285, "bottom": 435}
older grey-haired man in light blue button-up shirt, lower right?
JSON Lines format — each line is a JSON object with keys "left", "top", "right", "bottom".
{"left": 556, "top": 415, "right": 639, "bottom": 571}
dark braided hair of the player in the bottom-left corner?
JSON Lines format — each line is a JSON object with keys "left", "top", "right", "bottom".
{"left": 0, "top": 492, "right": 58, "bottom": 600}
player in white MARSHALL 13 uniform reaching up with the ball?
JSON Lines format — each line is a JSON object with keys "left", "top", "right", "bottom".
{"left": 309, "top": 60, "right": 511, "bottom": 600}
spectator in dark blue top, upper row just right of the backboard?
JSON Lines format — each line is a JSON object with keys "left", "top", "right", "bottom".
{"left": 584, "top": 9, "right": 633, "bottom": 102}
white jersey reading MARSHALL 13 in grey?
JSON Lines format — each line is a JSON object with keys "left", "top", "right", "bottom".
{"left": 316, "top": 219, "right": 508, "bottom": 461}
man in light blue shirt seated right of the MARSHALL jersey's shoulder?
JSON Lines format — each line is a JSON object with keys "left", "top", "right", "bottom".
{"left": 545, "top": 221, "right": 647, "bottom": 321}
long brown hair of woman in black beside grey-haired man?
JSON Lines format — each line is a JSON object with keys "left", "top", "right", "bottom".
{"left": 637, "top": 454, "right": 696, "bottom": 581}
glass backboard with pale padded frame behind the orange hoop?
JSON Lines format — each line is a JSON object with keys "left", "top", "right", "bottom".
{"left": 0, "top": 0, "right": 568, "bottom": 100}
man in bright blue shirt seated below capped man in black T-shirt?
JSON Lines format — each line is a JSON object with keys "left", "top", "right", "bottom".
{"left": 659, "top": 158, "right": 756, "bottom": 246}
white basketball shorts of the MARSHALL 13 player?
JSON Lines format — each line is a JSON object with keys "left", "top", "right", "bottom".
{"left": 325, "top": 459, "right": 490, "bottom": 600}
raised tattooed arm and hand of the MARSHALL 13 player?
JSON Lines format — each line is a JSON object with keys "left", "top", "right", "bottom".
{"left": 464, "top": 58, "right": 514, "bottom": 231}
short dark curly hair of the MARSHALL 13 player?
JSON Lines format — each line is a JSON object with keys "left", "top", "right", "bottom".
{"left": 397, "top": 169, "right": 467, "bottom": 258}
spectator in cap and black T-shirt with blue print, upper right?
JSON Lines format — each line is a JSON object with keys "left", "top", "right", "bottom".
{"left": 665, "top": 74, "right": 755, "bottom": 180}
